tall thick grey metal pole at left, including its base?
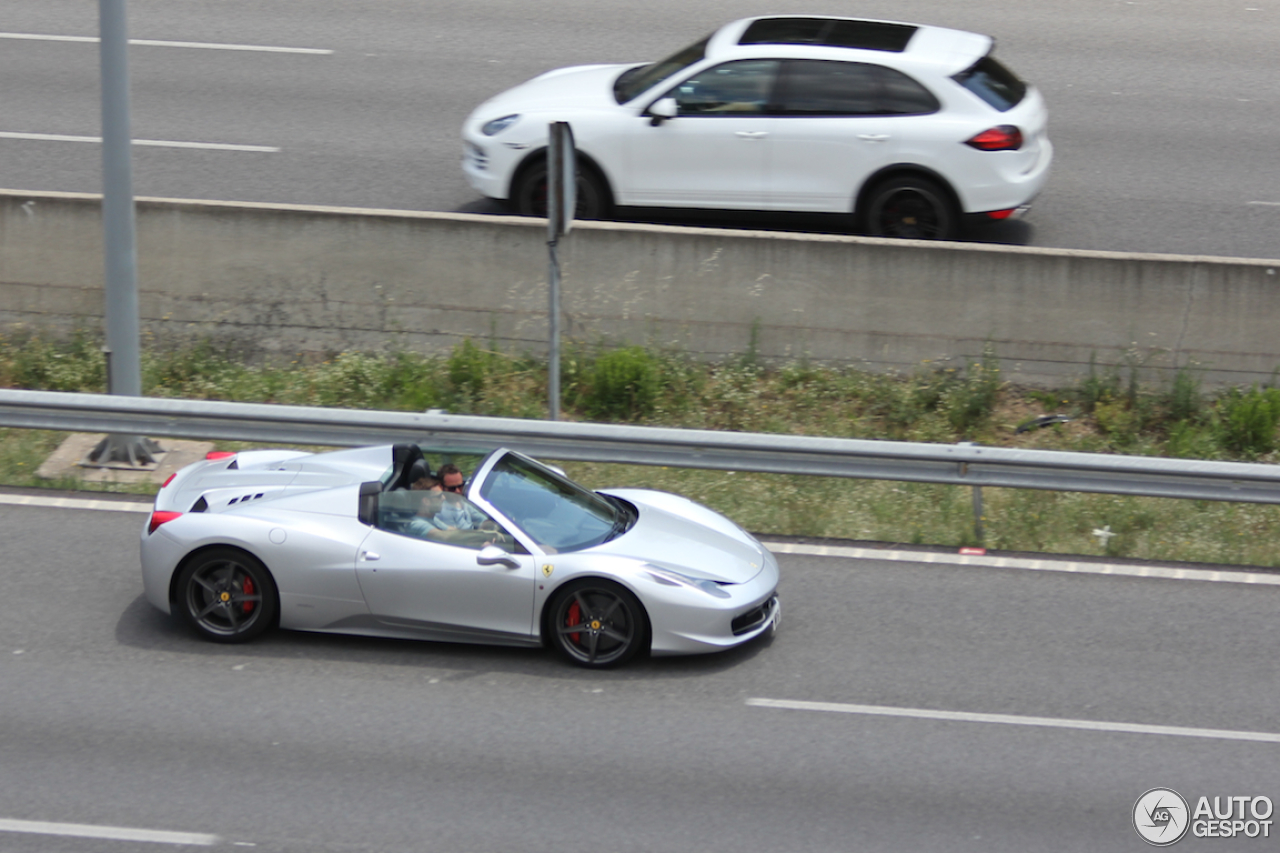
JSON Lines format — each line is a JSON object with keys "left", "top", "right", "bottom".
{"left": 86, "top": 0, "right": 159, "bottom": 466}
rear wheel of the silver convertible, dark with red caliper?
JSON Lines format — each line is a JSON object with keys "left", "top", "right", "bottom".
{"left": 175, "top": 548, "right": 279, "bottom": 643}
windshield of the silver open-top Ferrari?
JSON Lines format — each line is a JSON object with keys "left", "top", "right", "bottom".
{"left": 480, "top": 453, "right": 628, "bottom": 552}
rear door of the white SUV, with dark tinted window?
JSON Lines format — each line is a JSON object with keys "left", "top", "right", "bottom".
{"left": 769, "top": 59, "right": 940, "bottom": 213}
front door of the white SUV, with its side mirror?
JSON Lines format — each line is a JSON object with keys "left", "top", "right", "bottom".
{"left": 618, "top": 59, "right": 780, "bottom": 209}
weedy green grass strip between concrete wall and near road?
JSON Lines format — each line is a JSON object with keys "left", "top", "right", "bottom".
{"left": 0, "top": 336, "right": 1280, "bottom": 566}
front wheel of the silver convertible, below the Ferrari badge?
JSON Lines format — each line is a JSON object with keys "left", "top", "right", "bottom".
{"left": 548, "top": 579, "right": 649, "bottom": 669}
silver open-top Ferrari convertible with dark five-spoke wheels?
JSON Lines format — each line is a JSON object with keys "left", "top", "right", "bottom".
{"left": 141, "top": 444, "right": 781, "bottom": 667}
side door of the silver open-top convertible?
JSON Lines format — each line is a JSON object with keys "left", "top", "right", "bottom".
{"left": 356, "top": 491, "right": 535, "bottom": 640}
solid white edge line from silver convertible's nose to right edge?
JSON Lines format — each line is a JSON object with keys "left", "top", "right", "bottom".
{"left": 760, "top": 542, "right": 1280, "bottom": 587}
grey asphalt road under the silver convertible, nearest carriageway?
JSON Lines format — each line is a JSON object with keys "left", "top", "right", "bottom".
{"left": 0, "top": 506, "right": 1280, "bottom": 853}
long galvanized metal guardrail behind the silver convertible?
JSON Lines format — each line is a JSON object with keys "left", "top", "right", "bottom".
{"left": 0, "top": 389, "right": 1280, "bottom": 503}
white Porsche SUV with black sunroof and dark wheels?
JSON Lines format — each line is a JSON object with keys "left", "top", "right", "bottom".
{"left": 462, "top": 17, "right": 1053, "bottom": 240}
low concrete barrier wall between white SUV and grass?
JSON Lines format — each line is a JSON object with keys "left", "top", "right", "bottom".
{"left": 0, "top": 191, "right": 1280, "bottom": 384}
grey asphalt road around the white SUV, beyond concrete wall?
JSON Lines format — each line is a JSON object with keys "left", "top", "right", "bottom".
{"left": 0, "top": 0, "right": 1280, "bottom": 257}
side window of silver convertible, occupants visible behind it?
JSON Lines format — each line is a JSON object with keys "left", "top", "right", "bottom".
{"left": 376, "top": 491, "right": 527, "bottom": 553}
